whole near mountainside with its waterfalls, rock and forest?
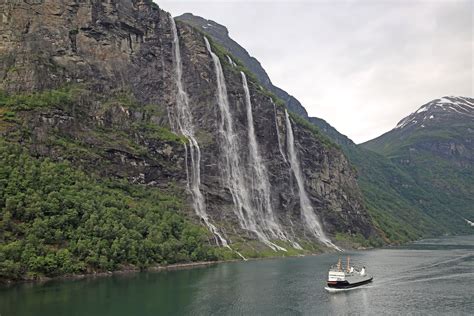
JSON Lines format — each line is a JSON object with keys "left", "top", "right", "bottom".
{"left": 0, "top": 0, "right": 379, "bottom": 279}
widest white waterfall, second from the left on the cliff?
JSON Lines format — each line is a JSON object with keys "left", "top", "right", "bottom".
{"left": 204, "top": 37, "right": 283, "bottom": 251}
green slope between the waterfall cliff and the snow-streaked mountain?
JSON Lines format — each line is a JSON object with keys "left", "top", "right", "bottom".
{"left": 343, "top": 145, "right": 446, "bottom": 243}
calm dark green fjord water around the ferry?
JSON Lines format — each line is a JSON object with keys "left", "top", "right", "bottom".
{"left": 0, "top": 236, "right": 474, "bottom": 316}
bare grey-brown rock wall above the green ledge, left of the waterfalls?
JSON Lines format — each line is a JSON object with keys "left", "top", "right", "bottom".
{"left": 0, "top": 0, "right": 171, "bottom": 103}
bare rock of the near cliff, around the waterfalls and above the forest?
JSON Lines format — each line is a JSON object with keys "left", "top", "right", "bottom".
{"left": 0, "top": 0, "right": 375, "bottom": 252}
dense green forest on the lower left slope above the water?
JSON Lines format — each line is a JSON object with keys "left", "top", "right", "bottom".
{"left": 0, "top": 140, "right": 217, "bottom": 279}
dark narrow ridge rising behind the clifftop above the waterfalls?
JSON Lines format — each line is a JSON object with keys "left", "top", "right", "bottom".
{"left": 176, "top": 13, "right": 308, "bottom": 118}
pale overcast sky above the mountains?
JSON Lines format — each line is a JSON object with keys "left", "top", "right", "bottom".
{"left": 155, "top": 0, "right": 474, "bottom": 143}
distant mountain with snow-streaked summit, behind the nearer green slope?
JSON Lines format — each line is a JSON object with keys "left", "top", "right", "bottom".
{"left": 362, "top": 96, "right": 474, "bottom": 232}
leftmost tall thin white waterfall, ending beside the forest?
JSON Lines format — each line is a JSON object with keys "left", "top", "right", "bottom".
{"left": 169, "top": 16, "right": 229, "bottom": 247}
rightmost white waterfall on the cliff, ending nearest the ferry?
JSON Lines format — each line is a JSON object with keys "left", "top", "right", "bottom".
{"left": 285, "top": 110, "right": 340, "bottom": 250}
